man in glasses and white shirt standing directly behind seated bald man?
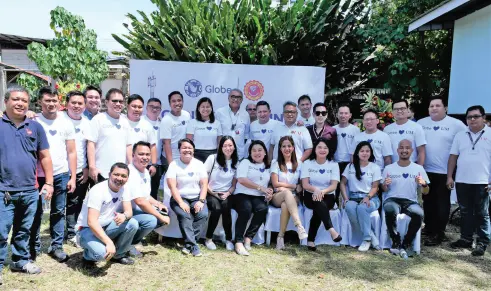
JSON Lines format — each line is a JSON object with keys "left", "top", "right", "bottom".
{"left": 384, "top": 100, "right": 426, "bottom": 165}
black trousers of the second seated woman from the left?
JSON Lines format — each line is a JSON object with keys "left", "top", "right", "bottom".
{"left": 206, "top": 194, "right": 233, "bottom": 240}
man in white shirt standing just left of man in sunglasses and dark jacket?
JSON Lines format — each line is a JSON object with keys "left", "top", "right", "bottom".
{"left": 269, "top": 101, "right": 312, "bottom": 162}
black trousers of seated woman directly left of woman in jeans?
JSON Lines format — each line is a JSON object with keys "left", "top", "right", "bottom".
{"left": 303, "top": 191, "right": 336, "bottom": 241}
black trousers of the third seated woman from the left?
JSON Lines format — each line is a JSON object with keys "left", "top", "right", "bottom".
{"left": 234, "top": 194, "right": 268, "bottom": 243}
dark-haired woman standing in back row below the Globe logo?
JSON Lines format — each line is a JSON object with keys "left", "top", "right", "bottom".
{"left": 186, "top": 97, "right": 222, "bottom": 163}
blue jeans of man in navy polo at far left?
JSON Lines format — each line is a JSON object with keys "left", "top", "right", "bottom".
{"left": 0, "top": 189, "right": 39, "bottom": 273}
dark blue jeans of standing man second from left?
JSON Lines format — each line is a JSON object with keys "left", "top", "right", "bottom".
{"left": 29, "top": 173, "right": 70, "bottom": 258}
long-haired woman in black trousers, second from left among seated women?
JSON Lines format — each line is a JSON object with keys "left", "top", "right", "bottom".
{"left": 205, "top": 135, "right": 239, "bottom": 251}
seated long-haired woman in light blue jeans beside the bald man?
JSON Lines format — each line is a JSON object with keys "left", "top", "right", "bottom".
{"left": 341, "top": 141, "right": 382, "bottom": 252}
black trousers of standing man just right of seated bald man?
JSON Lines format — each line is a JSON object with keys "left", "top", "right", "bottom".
{"left": 423, "top": 173, "right": 451, "bottom": 236}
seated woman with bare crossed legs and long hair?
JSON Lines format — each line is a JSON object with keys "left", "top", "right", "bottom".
{"left": 271, "top": 135, "right": 307, "bottom": 250}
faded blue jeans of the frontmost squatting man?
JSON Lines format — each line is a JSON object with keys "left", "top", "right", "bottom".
{"left": 79, "top": 218, "right": 138, "bottom": 262}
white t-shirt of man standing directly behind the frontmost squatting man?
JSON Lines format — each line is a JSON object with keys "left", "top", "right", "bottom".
{"left": 87, "top": 112, "right": 131, "bottom": 178}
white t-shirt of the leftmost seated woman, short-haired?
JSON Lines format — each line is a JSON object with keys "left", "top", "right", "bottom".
{"left": 165, "top": 158, "right": 208, "bottom": 199}
